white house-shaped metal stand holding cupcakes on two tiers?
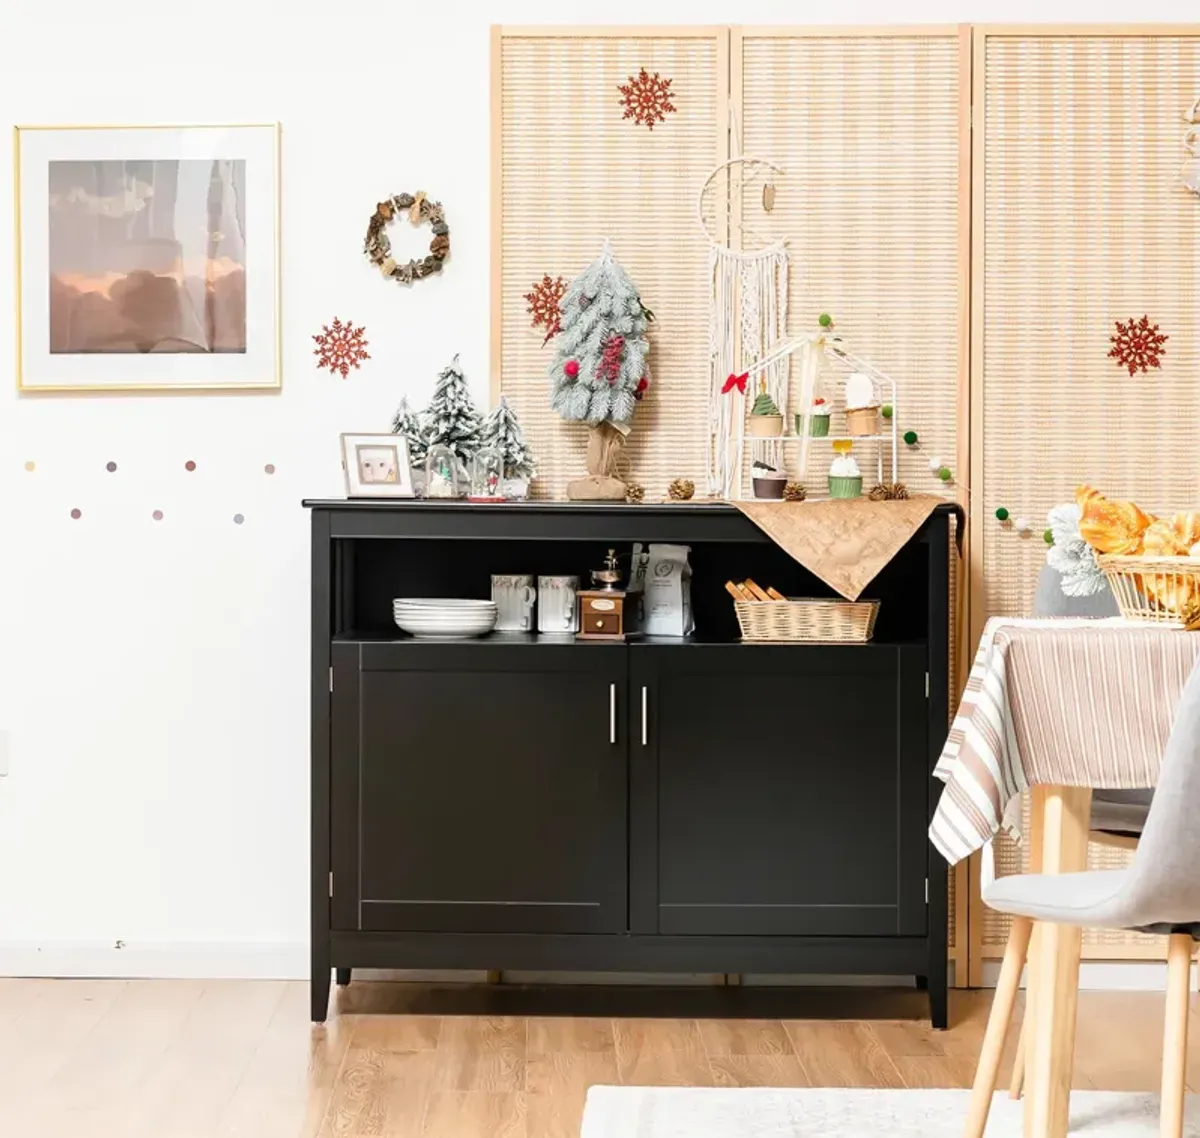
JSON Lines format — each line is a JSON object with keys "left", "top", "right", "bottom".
{"left": 726, "top": 315, "right": 900, "bottom": 499}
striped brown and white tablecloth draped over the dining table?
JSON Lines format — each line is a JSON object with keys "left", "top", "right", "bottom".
{"left": 929, "top": 617, "right": 1200, "bottom": 864}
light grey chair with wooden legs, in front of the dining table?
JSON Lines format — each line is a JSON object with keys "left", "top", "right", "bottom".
{"left": 966, "top": 665, "right": 1200, "bottom": 1138}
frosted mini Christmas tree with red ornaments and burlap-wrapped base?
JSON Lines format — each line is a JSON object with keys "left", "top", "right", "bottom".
{"left": 548, "top": 241, "right": 653, "bottom": 501}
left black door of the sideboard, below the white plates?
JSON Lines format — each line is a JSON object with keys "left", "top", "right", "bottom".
{"left": 332, "top": 641, "right": 628, "bottom": 933}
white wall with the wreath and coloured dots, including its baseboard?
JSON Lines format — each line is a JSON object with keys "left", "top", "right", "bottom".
{"left": 0, "top": 0, "right": 1200, "bottom": 975}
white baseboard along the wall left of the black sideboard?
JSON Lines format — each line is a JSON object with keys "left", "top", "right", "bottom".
{"left": 0, "top": 941, "right": 308, "bottom": 980}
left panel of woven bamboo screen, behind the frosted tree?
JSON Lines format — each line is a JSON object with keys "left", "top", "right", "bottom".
{"left": 492, "top": 28, "right": 728, "bottom": 498}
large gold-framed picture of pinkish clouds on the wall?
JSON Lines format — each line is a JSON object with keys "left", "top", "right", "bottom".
{"left": 13, "top": 124, "right": 280, "bottom": 391}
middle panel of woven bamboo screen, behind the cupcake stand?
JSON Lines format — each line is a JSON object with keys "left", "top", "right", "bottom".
{"left": 731, "top": 28, "right": 971, "bottom": 982}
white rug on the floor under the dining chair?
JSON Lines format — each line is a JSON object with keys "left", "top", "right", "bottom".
{"left": 581, "top": 1086, "right": 1200, "bottom": 1138}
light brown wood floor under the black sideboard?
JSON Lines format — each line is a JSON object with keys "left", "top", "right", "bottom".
{"left": 0, "top": 980, "right": 1200, "bottom": 1138}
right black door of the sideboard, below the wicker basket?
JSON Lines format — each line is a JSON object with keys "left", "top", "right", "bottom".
{"left": 630, "top": 643, "right": 929, "bottom": 936}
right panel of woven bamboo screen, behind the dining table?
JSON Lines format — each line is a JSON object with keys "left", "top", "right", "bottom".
{"left": 970, "top": 25, "right": 1200, "bottom": 982}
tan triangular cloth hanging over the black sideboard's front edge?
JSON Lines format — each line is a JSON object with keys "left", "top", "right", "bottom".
{"left": 733, "top": 495, "right": 946, "bottom": 600}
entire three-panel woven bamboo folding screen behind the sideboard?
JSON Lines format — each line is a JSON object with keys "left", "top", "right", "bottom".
{"left": 492, "top": 26, "right": 1200, "bottom": 983}
